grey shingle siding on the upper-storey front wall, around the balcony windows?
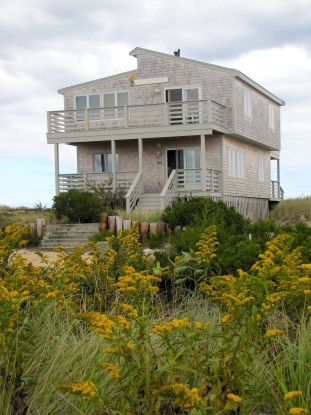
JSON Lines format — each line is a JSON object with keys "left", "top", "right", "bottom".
{"left": 64, "top": 54, "right": 233, "bottom": 128}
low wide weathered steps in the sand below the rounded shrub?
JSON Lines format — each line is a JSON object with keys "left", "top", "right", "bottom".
{"left": 40, "top": 223, "right": 99, "bottom": 251}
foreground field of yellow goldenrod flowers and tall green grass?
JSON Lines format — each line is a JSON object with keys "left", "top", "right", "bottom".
{"left": 0, "top": 214, "right": 311, "bottom": 415}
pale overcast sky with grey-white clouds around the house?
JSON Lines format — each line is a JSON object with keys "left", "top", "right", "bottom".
{"left": 0, "top": 0, "right": 311, "bottom": 207}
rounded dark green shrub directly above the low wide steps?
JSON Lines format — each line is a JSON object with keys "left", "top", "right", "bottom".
{"left": 53, "top": 189, "right": 103, "bottom": 223}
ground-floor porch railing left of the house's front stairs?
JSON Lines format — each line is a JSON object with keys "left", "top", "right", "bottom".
{"left": 58, "top": 171, "right": 137, "bottom": 192}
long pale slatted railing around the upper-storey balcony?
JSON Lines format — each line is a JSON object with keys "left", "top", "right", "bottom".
{"left": 48, "top": 100, "right": 227, "bottom": 134}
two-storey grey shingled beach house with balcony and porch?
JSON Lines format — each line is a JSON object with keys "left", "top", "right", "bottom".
{"left": 47, "top": 48, "right": 284, "bottom": 219}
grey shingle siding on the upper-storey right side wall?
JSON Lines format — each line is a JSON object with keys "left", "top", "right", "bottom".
{"left": 234, "top": 79, "right": 280, "bottom": 150}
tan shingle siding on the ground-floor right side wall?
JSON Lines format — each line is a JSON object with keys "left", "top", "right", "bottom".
{"left": 223, "top": 136, "right": 271, "bottom": 198}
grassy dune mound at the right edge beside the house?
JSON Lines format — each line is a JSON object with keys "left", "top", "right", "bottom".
{"left": 270, "top": 196, "right": 311, "bottom": 225}
